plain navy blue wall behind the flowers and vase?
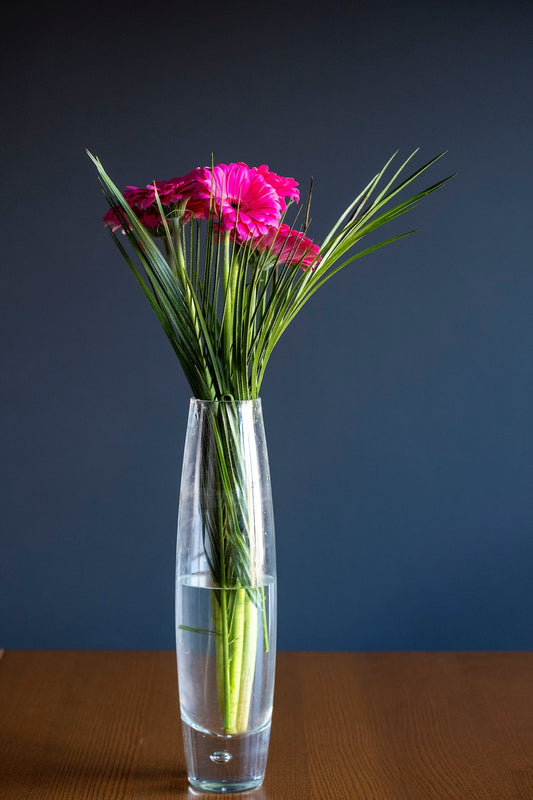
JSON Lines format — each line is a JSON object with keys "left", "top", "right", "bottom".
{"left": 0, "top": 2, "right": 533, "bottom": 650}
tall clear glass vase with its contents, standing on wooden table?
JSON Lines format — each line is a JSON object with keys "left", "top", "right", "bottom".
{"left": 176, "top": 399, "right": 276, "bottom": 793}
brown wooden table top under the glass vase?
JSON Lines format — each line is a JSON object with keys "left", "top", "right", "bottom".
{"left": 0, "top": 651, "right": 533, "bottom": 800}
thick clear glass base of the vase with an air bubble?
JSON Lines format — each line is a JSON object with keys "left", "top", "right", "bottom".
{"left": 182, "top": 719, "right": 270, "bottom": 794}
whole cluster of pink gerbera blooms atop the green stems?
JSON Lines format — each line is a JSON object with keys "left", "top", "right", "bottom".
{"left": 104, "top": 162, "right": 319, "bottom": 267}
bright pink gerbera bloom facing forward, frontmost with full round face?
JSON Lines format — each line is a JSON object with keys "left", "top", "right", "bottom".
{"left": 192, "top": 163, "right": 281, "bottom": 243}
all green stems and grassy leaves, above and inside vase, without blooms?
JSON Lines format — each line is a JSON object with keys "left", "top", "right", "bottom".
{"left": 89, "top": 150, "right": 452, "bottom": 734}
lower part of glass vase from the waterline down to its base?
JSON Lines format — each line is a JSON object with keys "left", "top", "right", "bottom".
{"left": 176, "top": 574, "right": 275, "bottom": 792}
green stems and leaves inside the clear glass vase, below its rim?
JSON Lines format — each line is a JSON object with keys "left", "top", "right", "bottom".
{"left": 199, "top": 402, "right": 270, "bottom": 734}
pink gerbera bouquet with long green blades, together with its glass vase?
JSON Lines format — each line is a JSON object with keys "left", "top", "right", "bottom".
{"left": 89, "top": 151, "right": 448, "bottom": 792}
